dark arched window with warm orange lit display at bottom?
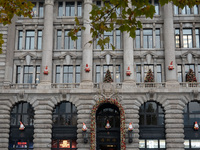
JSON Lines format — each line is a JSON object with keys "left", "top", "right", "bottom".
{"left": 52, "top": 102, "right": 77, "bottom": 150}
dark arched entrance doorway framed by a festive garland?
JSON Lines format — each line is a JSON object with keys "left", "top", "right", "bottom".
{"left": 96, "top": 103, "right": 120, "bottom": 150}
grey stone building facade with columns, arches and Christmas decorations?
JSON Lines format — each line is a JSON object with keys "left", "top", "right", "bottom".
{"left": 0, "top": 0, "right": 200, "bottom": 150}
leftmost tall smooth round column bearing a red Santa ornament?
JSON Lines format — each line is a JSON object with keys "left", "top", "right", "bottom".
{"left": 40, "top": 0, "right": 54, "bottom": 87}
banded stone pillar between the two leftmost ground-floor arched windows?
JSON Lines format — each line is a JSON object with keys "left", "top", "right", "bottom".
{"left": 33, "top": 99, "right": 53, "bottom": 150}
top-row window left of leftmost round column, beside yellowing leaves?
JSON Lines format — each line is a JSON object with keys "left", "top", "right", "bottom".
{"left": 32, "top": 2, "right": 44, "bottom": 17}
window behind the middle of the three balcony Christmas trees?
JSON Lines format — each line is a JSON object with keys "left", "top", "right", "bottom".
{"left": 136, "top": 64, "right": 162, "bottom": 83}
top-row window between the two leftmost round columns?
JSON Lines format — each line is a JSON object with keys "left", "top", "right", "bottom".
{"left": 58, "top": 1, "right": 82, "bottom": 17}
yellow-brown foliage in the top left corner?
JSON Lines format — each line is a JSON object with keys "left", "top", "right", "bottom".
{"left": 0, "top": 0, "right": 34, "bottom": 53}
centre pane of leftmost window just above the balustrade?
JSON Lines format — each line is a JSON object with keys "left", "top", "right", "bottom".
{"left": 23, "top": 66, "right": 33, "bottom": 83}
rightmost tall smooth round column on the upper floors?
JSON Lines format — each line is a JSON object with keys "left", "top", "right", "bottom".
{"left": 164, "top": 3, "right": 178, "bottom": 84}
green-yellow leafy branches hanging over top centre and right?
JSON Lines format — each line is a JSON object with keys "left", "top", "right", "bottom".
{"left": 69, "top": 0, "right": 200, "bottom": 50}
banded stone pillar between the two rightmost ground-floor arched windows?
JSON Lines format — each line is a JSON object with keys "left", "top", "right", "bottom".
{"left": 165, "top": 100, "right": 184, "bottom": 150}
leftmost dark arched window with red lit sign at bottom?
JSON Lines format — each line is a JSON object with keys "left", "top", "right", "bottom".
{"left": 9, "top": 102, "right": 34, "bottom": 150}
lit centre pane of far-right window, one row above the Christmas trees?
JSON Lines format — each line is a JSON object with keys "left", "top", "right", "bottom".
{"left": 183, "top": 29, "right": 193, "bottom": 48}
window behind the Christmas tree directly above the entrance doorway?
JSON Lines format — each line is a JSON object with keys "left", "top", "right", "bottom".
{"left": 95, "top": 65, "right": 121, "bottom": 83}
